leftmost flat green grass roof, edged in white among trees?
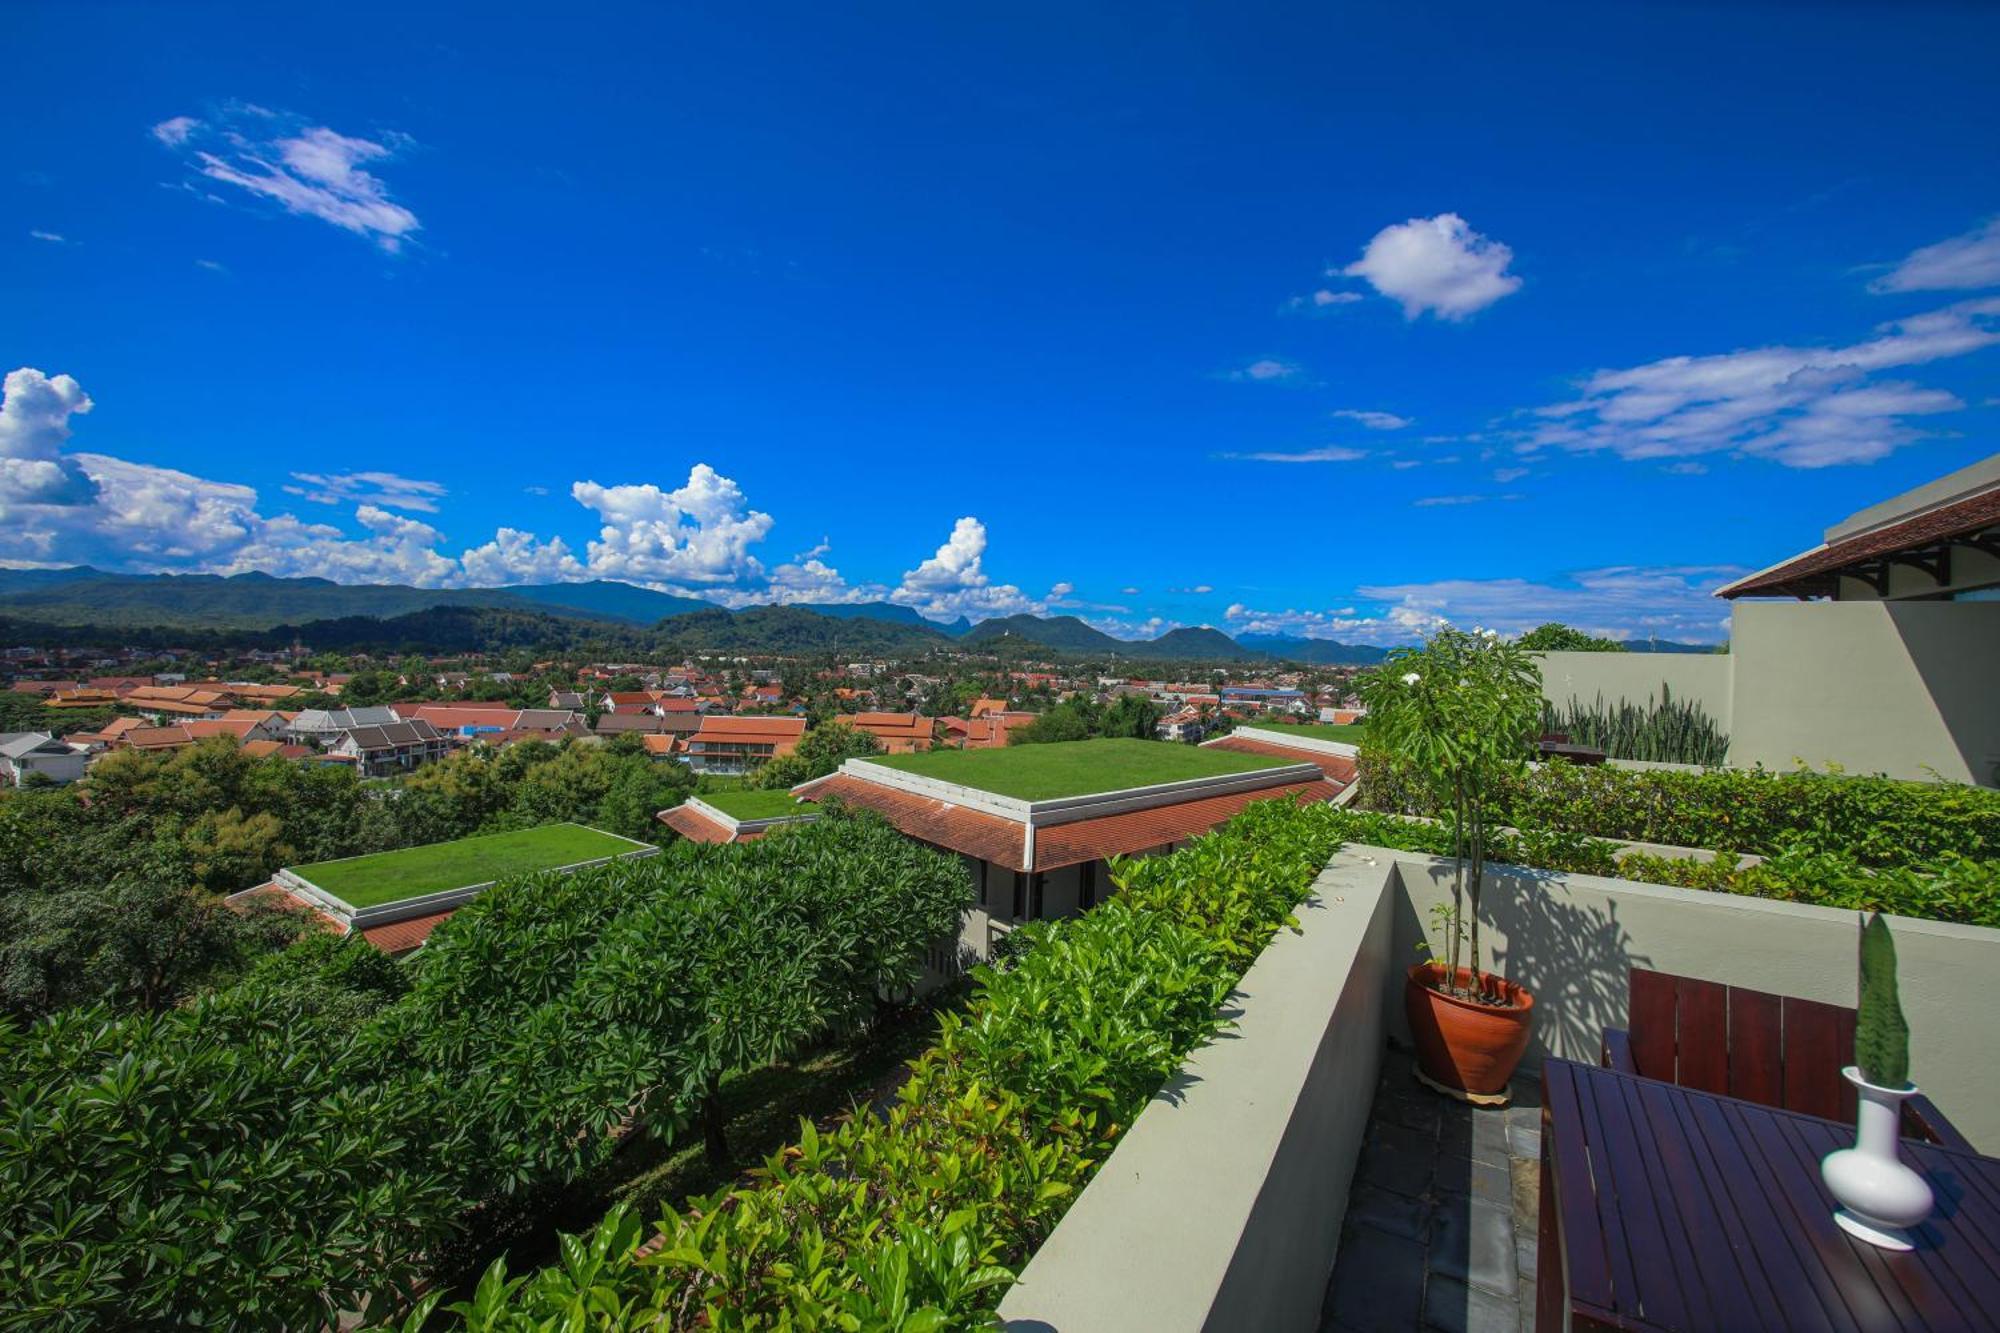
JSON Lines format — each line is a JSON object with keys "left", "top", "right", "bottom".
{"left": 288, "top": 825, "right": 646, "bottom": 907}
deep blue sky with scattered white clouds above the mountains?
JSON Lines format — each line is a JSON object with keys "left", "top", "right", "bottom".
{"left": 0, "top": 4, "right": 2000, "bottom": 642}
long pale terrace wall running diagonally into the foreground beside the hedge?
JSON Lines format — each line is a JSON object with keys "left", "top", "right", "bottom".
{"left": 1000, "top": 853, "right": 1398, "bottom": 1333}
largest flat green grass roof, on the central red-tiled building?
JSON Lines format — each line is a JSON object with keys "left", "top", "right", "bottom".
{"left": 868, "top": 741, "right": 1286, "bottom": 801}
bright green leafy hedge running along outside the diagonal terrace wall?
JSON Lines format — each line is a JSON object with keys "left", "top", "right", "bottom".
{"left": 430, "top": 801, "right": 1340, "bottom": 1331}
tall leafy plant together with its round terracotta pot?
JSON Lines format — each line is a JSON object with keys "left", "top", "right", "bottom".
{"left": 1360, "top": 628, "right": 1542, "bottom": 1105}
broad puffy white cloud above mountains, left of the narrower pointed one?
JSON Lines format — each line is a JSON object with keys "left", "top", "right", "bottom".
{"left": 570, "top": 462, "right": 772, "bottom": 586}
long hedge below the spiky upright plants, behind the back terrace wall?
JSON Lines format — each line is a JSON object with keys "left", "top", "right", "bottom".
{"left": 1360, "top": 747, "right": 2000, "bottom": 867}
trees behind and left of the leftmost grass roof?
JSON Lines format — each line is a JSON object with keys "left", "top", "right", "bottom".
{"left": 0, "top": 739, "right": 692, "bottom": 1019}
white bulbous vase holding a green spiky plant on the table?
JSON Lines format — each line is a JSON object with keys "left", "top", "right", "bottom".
{"left": 1820, "top": 913, "right": 1932, "bottom": 1249}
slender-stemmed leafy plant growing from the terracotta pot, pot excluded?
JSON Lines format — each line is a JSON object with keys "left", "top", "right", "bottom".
{"left": 1360, "top": 628, "right": 1542, "bottom": 999}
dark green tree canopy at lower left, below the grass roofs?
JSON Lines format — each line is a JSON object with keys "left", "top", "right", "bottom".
{"left": 0, "top": 817, "right": 970, "bottom": 1329}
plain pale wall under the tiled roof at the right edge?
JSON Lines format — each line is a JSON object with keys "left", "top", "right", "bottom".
{"left": 1720, "top": 602, "right": 2000, "bottom": 787}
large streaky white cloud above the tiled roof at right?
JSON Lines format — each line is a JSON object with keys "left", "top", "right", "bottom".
{"left": 1524, "top": 296, "right": 2000, "bottom": 468}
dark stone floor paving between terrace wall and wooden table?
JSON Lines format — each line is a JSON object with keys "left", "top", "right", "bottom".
{"left": 1320, "top": 1051, "right": 1542, "bottom": 1333}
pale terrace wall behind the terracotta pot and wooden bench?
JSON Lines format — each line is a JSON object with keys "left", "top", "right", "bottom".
{"left": 1384, "top": 849, "right": 2000, "bottom": 1151}
